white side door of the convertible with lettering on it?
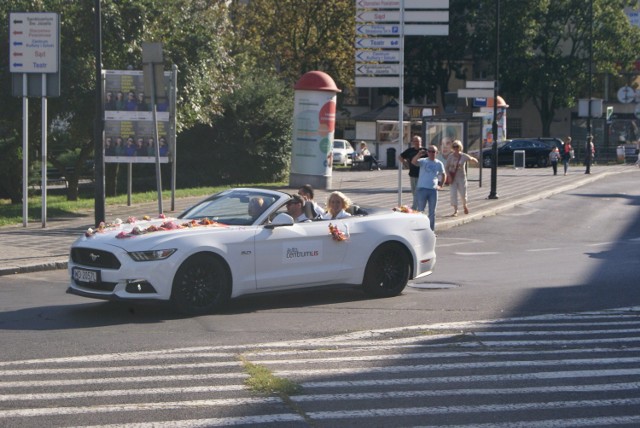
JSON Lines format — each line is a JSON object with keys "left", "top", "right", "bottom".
{"left": 255, "top": 221, "right": 350, "bottom": 289}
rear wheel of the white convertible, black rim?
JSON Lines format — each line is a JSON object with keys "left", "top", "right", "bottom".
{"left": 362, "top": 243, "right": 411, "bottom": 297}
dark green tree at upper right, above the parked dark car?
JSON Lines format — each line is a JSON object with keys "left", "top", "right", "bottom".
{"left": 485, "top": 0, "right": 640, "bottom": 136}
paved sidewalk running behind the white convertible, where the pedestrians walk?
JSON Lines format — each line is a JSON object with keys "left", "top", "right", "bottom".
{"left": 0, "top": 165, "right": 638, "bottom": 275}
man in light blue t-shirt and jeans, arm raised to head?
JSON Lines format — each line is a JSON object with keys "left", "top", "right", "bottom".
{"left": 411, "top": 145, "right": 447, "bottom": 231}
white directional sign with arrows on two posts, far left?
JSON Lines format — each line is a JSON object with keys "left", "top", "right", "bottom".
{"left": 9, "top": 13, "right": 60, "bottom": 73}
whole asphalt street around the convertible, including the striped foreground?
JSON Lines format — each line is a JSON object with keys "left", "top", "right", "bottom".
{"left": 0, "top": 173, "right": 640, "bottom": 427}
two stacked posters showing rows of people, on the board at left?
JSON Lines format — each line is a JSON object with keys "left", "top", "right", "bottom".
{"left": 104, "top": 70, "right": 175, "bottom": 163}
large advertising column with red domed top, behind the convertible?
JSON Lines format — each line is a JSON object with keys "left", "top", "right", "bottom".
{"left": 289, "top": 71, "right": 340, "bottom": 189}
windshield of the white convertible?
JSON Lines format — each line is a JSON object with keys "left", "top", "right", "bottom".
{"left": 178, "top": 190, "right": 277, "bottom": 226}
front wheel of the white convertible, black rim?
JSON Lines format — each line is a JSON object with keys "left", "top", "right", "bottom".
{"left": 171, "top": 254, "right": 231, "bottom": 315}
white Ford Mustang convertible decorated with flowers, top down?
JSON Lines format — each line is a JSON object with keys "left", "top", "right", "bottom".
{"left": 67, "top": 188, "right": 436, "bottom": 314}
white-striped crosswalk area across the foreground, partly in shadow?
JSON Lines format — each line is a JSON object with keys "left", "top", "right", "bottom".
{"left": 0, "top": 308, "right": 640, "bottom": 428}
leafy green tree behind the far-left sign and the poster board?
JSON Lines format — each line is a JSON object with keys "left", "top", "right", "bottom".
{"left": 0, "top": 0, "right": 234, "bottom": 199}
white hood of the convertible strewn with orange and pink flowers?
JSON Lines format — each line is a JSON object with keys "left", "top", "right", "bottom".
{"left": 73, "top": 217, "right": 246, "bottom": 250}
